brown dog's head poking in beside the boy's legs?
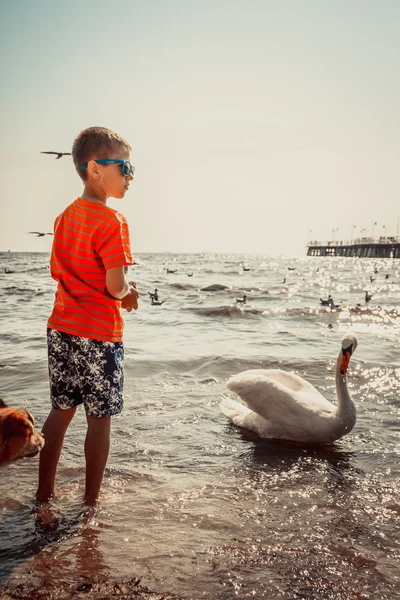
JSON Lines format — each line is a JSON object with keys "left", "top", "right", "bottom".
{"left": 0, "top": 400, "right": 44, "bottom": 467}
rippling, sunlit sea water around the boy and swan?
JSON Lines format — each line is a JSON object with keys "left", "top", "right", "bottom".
{"left": 0, "top": 253, "right": 400, "bottom": 600}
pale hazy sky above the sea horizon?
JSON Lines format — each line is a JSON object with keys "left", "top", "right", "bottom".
{"left": 0, "top": 0, "right": 400, "bottom": 256}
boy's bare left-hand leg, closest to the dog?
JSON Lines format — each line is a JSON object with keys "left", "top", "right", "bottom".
{"left": 36, "top": 407, "right": 76, "bottom": 502}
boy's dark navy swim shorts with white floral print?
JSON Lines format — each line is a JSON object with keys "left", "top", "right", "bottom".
{"left": 47, "top": 328, "right": 124, "bottom": 417}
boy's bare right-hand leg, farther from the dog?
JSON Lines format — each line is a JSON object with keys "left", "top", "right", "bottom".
{"left": 85, "top": 415, "right": 111, "bottom": 506}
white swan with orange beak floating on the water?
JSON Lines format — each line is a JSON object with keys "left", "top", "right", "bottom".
{"left": 220, "top": 334, "right": 357, "bottom": 444}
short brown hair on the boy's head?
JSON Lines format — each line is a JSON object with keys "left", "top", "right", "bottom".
{"left": 72, "top": 127, "right": 132, "bottom": 181}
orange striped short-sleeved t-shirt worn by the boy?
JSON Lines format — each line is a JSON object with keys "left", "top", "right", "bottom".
{"left": 47, "top": 198, "right": 133, "bottom": 342}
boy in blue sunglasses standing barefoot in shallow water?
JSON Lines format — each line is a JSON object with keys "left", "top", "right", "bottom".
{"left": 36, "top": 127, "right": 138, "bottom": 505}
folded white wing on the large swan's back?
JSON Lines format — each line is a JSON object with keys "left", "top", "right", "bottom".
{"left": 227, "top": 369, "right": 336, "bottom": 427}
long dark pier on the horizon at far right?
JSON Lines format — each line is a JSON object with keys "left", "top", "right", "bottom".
{"left": 307, "top": 236, "right": 400, "bottom": 258}
